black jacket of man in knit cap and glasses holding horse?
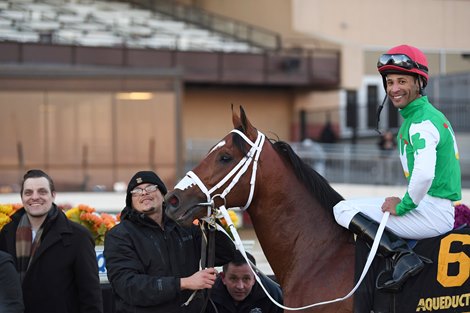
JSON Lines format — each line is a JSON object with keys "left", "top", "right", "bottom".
{"left": 104, "top": 207, "right": 234, "bottom": 313}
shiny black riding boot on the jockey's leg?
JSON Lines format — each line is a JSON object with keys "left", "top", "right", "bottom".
{"left": 349, "top": 213, "right": 424, "bottom": 292}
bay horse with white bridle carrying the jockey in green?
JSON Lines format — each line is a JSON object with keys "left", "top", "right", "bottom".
{"left": 165, "top": 107, "right": 470, "bottom": 313}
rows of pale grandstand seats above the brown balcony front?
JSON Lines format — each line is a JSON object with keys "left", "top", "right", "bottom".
{"left": 0, "top": 0, "right": 261, "bottom": 53}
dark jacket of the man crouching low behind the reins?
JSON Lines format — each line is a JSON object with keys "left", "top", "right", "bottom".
{"left": 206, "top": 276, "right": 284, "bottom": 313}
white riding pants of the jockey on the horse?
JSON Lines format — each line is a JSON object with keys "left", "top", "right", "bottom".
{"left": 333, "top": 195, "right": 455, "bottom": 239}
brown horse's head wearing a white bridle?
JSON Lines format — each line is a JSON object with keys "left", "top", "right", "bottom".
{"left": 165, "top": 107, "right": 264, "bottom": 225}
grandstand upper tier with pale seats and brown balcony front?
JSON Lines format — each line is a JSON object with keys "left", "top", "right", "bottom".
{"left": 0, "top": 0, "right": 339, "bottom": 89}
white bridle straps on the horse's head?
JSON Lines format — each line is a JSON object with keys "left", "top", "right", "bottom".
{"left": 175, "top": 129, "right": 266, "bottom": 216}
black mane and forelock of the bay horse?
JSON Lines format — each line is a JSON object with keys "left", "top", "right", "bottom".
{"left": 233, "top": 129, "right": 344, "bottom": 214}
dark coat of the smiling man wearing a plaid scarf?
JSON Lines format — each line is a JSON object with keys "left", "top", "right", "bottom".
{"left": 0, "top": 205, "right": 103, "bottom": 313}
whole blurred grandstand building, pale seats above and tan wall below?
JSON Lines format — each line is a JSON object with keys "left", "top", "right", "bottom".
{"left": 0, "top": 0, "right": 340, "bottom": 191}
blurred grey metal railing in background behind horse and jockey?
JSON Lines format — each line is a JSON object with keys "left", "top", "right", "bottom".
{"left": 185, "top": 140, "right": 470, "bottom": 188}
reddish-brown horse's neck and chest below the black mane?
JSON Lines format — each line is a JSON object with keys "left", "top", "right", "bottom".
{"left": 242, "top": 146, "right": 354, "bottom": 312}
